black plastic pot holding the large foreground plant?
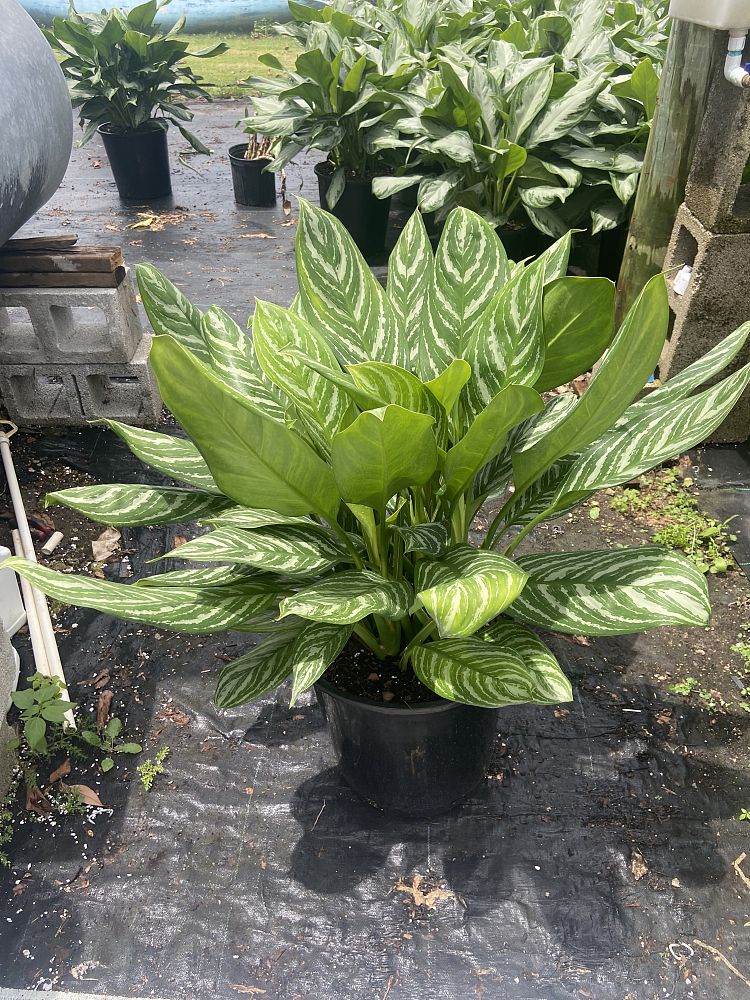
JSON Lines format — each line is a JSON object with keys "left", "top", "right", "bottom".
{"left": 315, "top": 680, "right": 499, "bottom": 816}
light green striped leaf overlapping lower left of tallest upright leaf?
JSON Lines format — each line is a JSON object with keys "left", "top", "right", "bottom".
{"left": 253, "top": 300, "right": 350, "bottom": 447}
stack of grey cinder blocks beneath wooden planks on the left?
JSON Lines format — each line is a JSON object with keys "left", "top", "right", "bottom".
{"left": 0, "top": 250, "right": 161, "bottom": 425}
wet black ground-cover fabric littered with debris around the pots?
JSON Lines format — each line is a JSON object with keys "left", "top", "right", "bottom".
{"left": 0, "top": 104, "right": 750, "bottom": 1000}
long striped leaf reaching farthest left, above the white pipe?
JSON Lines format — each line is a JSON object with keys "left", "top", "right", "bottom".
{"left": 4, "top": 557, "right": 276, "bottom": 633}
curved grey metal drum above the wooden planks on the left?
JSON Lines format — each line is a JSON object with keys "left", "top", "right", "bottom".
{"left": 0, "top": 0, "right": 73, "bottom": 245}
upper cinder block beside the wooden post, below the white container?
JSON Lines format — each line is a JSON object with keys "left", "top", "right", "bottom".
{"left": 685, "top": 51, "right": 750, "bottom": 233}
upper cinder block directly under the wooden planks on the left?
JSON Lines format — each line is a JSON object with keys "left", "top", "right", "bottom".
{"left": 0, "top": 272, "right": 143, "bottom": 365}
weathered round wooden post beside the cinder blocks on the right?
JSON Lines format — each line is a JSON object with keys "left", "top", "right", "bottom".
{"left": 617, "top": 21, "right": 726, "bottom": 320}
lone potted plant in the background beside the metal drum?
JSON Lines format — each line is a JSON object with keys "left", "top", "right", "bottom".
{"left": 43, "top": 0, "right": 227, "bottom": 201}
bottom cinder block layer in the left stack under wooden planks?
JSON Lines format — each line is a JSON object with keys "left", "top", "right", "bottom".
{"left": 0, "top": 337, "right": 161, "bottom": 427}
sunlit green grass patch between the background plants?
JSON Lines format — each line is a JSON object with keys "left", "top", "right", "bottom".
{"left": 184, "top": 31, "right": 300, "bottom": 97}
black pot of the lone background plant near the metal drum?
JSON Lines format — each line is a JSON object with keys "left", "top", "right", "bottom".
{"left": 97, "top": 122, "right": 172, "bottom": 201}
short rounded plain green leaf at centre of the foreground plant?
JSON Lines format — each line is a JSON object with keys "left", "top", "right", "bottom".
{"left": 331, "top": 405, "right": 438, "bottom": 510}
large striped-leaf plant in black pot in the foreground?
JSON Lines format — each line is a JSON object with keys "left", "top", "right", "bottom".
{"left": 8, "top": 201, "right": 750, "bottom": 815}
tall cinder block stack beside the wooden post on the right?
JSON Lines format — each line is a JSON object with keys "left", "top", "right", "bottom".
{"left": 659, "top": 59, "right": 750, "bottom": 443}
